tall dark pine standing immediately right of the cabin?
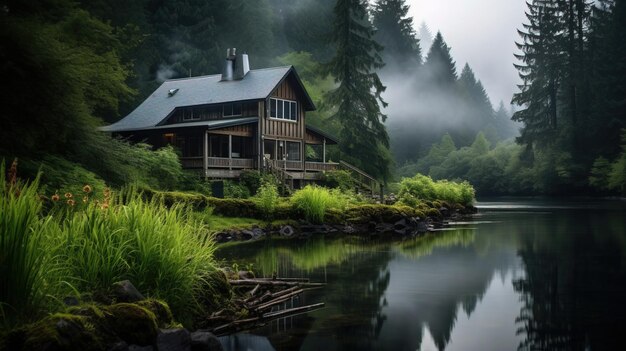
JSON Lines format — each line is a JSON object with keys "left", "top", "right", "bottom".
{"left": 326, "top": 0, "right": 391, "bottom": 181}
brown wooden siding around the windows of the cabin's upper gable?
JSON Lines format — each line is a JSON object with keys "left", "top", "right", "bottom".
{"left": 261, "top": 78, "right": 306, "bottom": 140}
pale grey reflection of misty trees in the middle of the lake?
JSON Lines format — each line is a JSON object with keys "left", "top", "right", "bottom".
{"left": 380, "top": 229, "right": 514, "bottom": 350}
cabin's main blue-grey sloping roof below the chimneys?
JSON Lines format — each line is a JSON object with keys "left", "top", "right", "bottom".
{"left": 100, "top": 66, "right": 315, "bottom": 132}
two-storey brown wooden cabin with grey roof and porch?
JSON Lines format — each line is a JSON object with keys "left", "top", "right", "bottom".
{"left": 102, "top": 49, "right": 358, "bottom": 190}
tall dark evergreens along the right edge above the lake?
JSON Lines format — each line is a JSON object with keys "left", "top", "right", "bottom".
{"left": 513, "top": 0, "right": 626, "bottom": 193}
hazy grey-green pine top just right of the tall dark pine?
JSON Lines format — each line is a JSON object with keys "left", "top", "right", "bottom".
{"left": 372, "top": 0, "right": 422, "bottom": 73}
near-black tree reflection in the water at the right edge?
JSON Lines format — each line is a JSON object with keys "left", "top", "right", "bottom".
{"left": 514, "top": 212, "right": 626, "bottom": 350}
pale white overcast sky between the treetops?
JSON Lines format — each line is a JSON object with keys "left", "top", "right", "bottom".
{"left": 407, "top": 0, "right": 526, "bottom": 108}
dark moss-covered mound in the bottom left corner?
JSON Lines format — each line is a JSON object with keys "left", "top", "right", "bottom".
{"left": 0, "top": 313, "right": 106, "bottom": 351}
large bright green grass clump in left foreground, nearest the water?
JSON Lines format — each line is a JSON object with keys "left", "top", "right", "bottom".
{"left": 50, "top": 190, "right": 216, "bottom": 322}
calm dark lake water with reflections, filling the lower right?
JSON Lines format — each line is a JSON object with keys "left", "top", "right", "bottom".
{"left": 213, "top": 199, "right": 626, "bottom": 351}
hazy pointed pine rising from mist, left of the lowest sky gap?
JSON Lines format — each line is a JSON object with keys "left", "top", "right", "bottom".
{"left": 424, "top": 32, "right": 457, "bottom": 86}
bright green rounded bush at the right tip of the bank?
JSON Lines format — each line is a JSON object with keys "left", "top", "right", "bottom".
{"left": 398, "top": 174, "right": 475, "bottom": 207}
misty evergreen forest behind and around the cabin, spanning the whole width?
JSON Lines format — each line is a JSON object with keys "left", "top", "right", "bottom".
{"left": 0, "top": 0, "right": 626, "bottom": 195}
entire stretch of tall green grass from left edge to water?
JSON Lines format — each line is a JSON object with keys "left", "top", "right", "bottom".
{"left": 0, "top": 165, "right": 219, "bottom": 325}
